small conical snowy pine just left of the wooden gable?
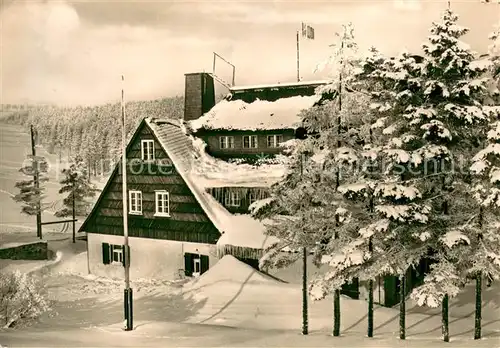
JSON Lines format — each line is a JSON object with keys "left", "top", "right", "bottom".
{"left": 55, "top": 156, "right": 96, "bottom": 243}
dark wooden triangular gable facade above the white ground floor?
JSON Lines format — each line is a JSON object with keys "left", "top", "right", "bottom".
{"left": 85, "top": 123, "right": 220, "bottom": 244}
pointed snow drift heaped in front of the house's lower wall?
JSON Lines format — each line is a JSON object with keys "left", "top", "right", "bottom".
{"left": 186, "top": 255, "right": 282, "bottom": 290}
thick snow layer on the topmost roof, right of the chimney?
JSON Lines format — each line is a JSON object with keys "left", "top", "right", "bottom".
{"left": 190, "top": 95, "right": 320, "bottom": 132}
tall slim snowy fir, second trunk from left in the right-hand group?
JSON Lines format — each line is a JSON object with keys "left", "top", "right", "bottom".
{"left": 296, "top": 24, "right": 376, "bottom": 336}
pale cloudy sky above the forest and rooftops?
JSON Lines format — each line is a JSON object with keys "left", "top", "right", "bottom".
{"left": 0, "top": 0, "right": 500, "bottom": 105}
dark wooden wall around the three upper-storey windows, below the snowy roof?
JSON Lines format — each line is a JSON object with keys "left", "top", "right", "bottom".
{"left": 202, "top": 129, "right": 295, "bottom": 158}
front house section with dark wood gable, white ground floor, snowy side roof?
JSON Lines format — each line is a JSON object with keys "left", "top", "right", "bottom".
{"left": 80, "top": 119, "right": 273, "bottom": 279}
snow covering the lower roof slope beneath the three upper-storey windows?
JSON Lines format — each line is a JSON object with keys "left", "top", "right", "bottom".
{"left": 191, "top": 137, "right": 286, "bottom": 188}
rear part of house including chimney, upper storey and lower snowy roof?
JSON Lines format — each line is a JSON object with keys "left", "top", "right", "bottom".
{"left": 184, "top": 73, "right": 327, "bottom": 213}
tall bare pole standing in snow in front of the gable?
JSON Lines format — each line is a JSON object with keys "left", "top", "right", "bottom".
{"left": 121, "top": 75, "right": 133, "bottom": 331}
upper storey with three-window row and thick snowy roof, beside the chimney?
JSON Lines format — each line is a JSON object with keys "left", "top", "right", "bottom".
{"left": 185, "top": 79, "right": 326, "bottom": 159}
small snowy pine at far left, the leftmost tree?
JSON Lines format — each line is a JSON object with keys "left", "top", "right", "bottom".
{"left": 12, "top": 155, "right": 49, "bottom": 238}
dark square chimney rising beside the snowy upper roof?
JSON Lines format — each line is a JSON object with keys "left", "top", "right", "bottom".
{"left": 184, "top": 73, "right": 215, "bottom": 121}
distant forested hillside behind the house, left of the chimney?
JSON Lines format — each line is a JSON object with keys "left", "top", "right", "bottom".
{"left": 0, "top": 96, "right": 184, "bottom": 179}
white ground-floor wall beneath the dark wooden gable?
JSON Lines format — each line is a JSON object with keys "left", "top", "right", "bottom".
{"left": 87, "top": 233, "right": 217, "bottom": 280}
